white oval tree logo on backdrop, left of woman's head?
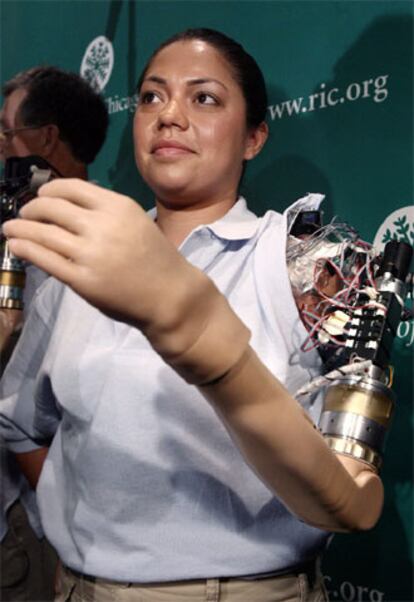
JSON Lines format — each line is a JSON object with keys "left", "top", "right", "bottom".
{"left": 80, "top": 36, "right": 114, "bottom": 92}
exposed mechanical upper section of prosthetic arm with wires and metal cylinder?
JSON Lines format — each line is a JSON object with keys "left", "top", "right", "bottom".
{"left": 287, "top": 211, "right": 412, "bottom": 470}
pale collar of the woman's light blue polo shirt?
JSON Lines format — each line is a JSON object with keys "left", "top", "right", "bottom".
{"left": 148, "top": 196, "right": 261, "bottom": 240}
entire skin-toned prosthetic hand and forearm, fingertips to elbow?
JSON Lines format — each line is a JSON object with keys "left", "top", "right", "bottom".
{"left": 4, "top": 180, "right": 383, "bottom": 531}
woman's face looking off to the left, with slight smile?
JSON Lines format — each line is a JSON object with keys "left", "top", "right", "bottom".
{"left": 134, "top": 40, "right": 264, "bottom": 207}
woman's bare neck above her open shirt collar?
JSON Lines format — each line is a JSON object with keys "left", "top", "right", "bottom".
{"left": 156, "top": 196, "right": 236, "bottom": 248}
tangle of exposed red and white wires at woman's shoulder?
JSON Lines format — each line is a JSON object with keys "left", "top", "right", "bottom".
{"left": 286, "top": 219, "right": 380, "bottom": 351}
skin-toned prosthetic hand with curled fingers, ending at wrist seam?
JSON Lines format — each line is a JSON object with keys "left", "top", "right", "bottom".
{"left": 4, "top": 179, "right": 249, "bottom": 384}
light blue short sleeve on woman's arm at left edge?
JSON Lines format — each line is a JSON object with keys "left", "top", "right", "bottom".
{"left": 0, "top": 278, "right": 63, "bottom": 453}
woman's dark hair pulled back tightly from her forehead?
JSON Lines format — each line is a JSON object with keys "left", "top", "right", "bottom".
{"left": 137, "top": 27, "right": 267, "bottom": 128}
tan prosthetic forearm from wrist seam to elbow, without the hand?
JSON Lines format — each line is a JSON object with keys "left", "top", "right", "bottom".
{"left": 200, "top": 348, "right": 383, "bottom": 531}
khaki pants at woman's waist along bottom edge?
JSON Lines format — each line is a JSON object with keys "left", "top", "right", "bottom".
{"left": 55, "top": 568, "right": 328, "bottom": 602}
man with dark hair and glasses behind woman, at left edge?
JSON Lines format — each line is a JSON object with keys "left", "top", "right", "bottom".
{"left": 0, "top": 66, "right": 108, "bottom": 602}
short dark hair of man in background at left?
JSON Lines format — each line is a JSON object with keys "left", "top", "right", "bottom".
{"left": 3, "top": 66, "right": 109, "bottom": 164}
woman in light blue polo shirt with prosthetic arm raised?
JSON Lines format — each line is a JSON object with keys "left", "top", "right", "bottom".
{"left": 3, "top": 30, "right": 381, "bottom": 602}
